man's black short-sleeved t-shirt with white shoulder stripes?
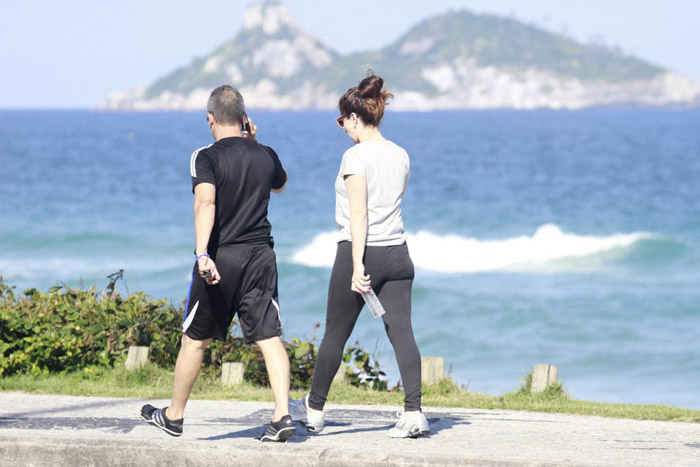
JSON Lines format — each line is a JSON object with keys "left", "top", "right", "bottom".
{"left": 190, "top": 137, "right": 286, "bottom": 254}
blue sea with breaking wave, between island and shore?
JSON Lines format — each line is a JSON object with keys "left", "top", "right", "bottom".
{"left": 0, "top": 110, "right": 700, "bottom": 409}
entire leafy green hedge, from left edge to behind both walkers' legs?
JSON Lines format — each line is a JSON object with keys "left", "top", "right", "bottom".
{"left": 0, "top": 278, "right": 386, "bottom": 389}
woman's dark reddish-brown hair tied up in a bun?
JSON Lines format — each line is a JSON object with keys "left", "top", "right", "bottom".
{"left": 338, "top": 70, "right": 394, "bottom": 126}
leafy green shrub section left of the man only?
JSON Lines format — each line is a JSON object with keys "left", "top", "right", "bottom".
{"left": 0, "top": 277, "right": 181, "bottom": 375}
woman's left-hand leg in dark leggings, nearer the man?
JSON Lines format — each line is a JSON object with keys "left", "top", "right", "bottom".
{"left": 309, "top": 242, "right": 364, "bottom": 410}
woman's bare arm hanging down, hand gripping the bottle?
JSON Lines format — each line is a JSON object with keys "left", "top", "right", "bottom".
{"left": 345, "top": 175, "right": 370, "bottom": 293}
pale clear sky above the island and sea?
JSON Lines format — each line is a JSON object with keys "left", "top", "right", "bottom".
{"left": 0, "top": 0, "right": 700, "bottom": 109}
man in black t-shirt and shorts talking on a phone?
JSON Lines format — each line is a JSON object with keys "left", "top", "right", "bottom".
{"left": 141, "top": 86, "right": 294, "bottom": 442}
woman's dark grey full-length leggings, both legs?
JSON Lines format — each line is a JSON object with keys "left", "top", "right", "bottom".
{"left": 309, "top": 242, "right": 421, "bottom": 411}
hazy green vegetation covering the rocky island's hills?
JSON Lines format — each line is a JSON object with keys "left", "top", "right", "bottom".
{"left": 145, "top": 6, "right": 664, "bottom": 103}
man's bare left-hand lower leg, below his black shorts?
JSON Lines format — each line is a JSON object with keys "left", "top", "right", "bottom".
{"left": 165, "top": 334, "right": 212, "bottom": 420}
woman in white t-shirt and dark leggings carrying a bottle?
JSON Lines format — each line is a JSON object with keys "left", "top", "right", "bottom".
{"left": 290, "top": 75, "right": 430, "bottom": 438}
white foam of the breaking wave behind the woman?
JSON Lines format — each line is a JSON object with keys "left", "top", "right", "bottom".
{"left": 291, "top": 224, "right": 659, "bottom": 273}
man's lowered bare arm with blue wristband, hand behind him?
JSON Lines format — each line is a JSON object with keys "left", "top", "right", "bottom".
{"left": 194, "top": 183, "right": 221, "bottom": 284}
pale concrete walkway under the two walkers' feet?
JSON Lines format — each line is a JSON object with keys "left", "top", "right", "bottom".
{"left": 0, "top": 392, "right": 700, "bottom": 467}
